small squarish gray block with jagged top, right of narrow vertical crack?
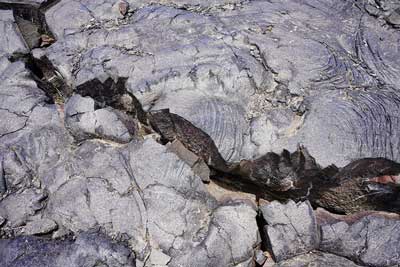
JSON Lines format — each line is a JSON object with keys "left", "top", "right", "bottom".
{"left": 260, "top": 200, "right": 320, "bottom": 262}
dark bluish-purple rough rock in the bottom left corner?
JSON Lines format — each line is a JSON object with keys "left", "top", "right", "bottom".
{"left": 0, "top": 233, "right": 136, "bottom": 267}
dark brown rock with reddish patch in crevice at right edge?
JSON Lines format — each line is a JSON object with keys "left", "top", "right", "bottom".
{"left": 312, "top": 158, "right": 400, "bottom": 213}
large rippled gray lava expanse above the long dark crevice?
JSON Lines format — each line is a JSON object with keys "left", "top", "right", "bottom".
{"left": 36, "top": 0, "right": 400, "bottom": 166}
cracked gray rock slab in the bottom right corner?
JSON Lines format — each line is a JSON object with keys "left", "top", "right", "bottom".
{"left": 319, "top": 212, "right": 400, "bottom": 266}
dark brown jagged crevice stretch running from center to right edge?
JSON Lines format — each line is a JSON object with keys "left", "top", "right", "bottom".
{"left": 149, "top": 109, "right": 400, "bottom": 216}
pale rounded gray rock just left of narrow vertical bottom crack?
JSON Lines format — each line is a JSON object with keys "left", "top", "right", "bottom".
{"left": 169, "top": 201, "right": 260, "bottom": 267}
